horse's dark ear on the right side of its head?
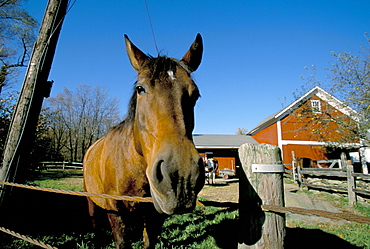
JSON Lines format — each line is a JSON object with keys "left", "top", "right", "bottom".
{"left": 181, "top": 33, "right": 203, "bottom": 72}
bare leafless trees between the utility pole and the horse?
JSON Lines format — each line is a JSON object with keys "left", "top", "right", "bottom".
{"left": 47, "top": 85, "right": 119, "bottom": 161}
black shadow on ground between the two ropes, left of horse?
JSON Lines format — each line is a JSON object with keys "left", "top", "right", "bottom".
{"left": 0, "top": 189, "right": 90, "bottom": 235}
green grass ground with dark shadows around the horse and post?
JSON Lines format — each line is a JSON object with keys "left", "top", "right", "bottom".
{"left": 0, "top": 171, "right": 370, "bottom": 249}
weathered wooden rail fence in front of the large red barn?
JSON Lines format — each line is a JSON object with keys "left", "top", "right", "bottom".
{"left": 291, "top": 155, "right": 370, "bottom": 206}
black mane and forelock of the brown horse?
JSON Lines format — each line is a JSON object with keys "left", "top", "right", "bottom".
{"left": 112, "top": 55, "right": 191, "bottom": 130}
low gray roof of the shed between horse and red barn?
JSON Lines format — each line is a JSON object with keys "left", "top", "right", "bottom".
{"left": 193, "top": 134, "right": 258, "bottom": 149}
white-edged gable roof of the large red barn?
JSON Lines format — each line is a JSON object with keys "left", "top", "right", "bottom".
{"left": 248, "top": 86, "right": 358, "bottom": 135}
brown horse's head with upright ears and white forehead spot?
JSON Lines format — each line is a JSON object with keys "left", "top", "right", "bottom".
{"left": 125, "top": 34, "right": 204, "bottom": 214}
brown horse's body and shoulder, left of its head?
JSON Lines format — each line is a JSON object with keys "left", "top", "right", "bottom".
{"left": 84, "top": 126, "right": 149, "bottom": 210}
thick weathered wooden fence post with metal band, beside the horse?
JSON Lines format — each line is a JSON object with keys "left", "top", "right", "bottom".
{"left": 238, "top": 144, "right": 285, "bottom": 249}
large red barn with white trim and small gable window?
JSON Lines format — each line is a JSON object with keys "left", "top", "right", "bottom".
{"left": 248, "top": 87, "right": 360, "bottom": 164}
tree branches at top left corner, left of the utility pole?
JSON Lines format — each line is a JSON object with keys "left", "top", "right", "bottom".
{"left": 0, "top": 0, "right": 37, "bottom": 92}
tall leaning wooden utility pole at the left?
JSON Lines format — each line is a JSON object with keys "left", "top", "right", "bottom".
{"left": 0, "top": 0, "right": 68, "bottom": 202}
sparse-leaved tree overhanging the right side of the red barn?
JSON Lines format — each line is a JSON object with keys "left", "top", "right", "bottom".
{"left": 295, "top": 34, "right": 370, "bottom": 146}
